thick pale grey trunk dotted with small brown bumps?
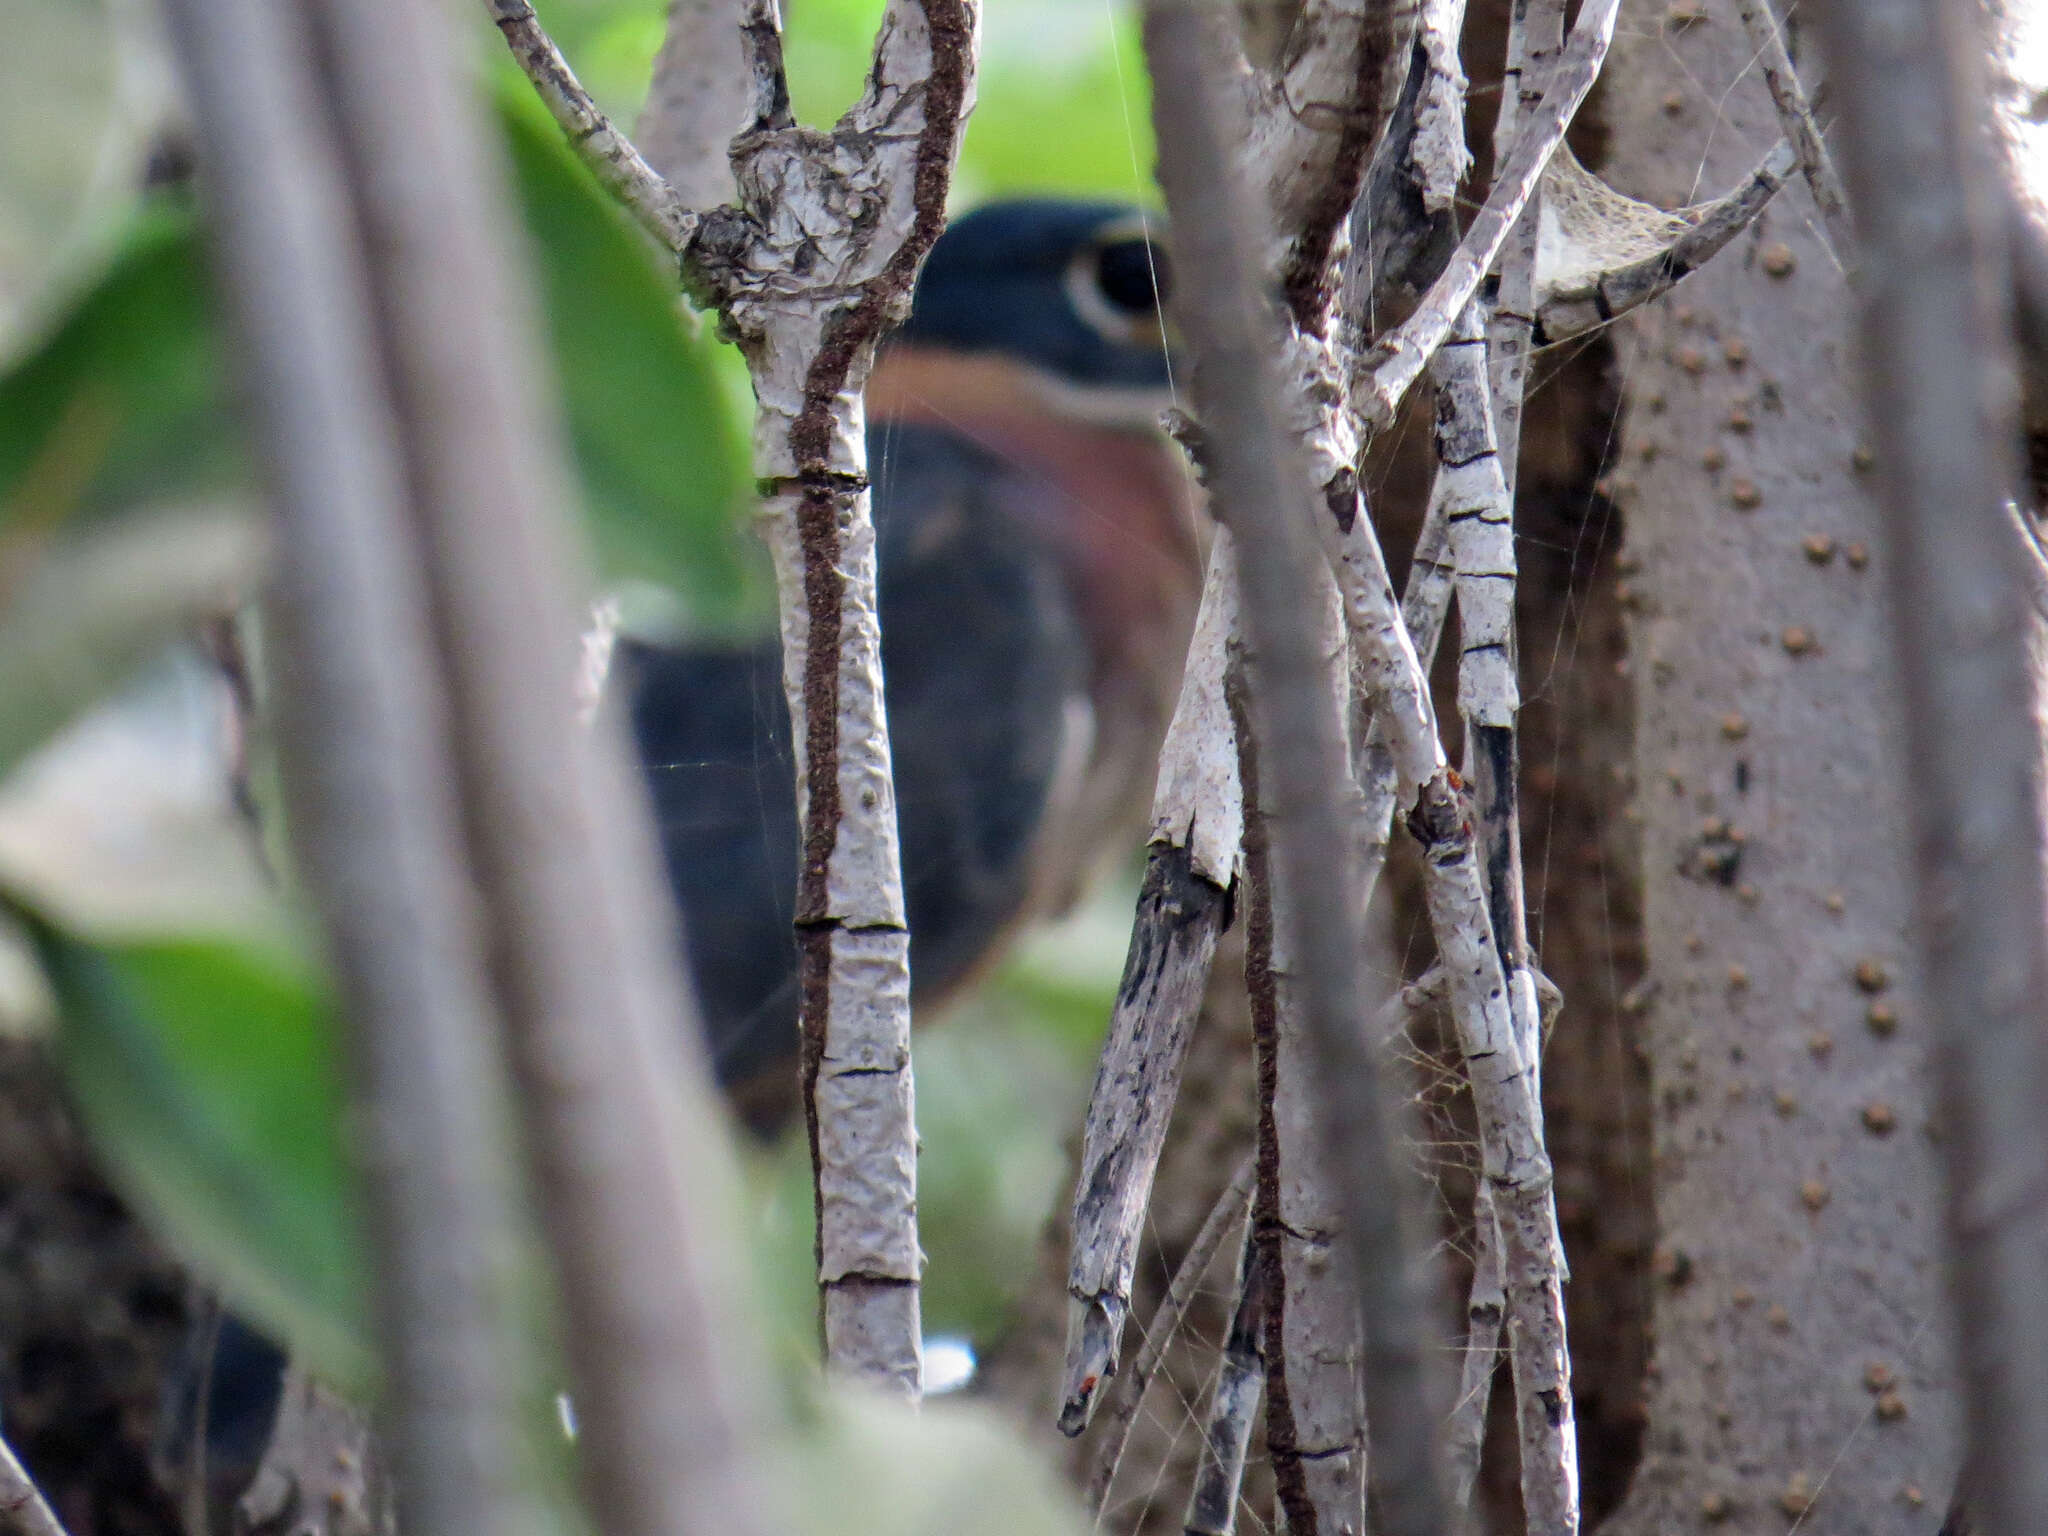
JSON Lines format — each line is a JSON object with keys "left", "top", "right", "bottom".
{"left": 1604, "top": 2, "right": 1958, "bottom": 1536}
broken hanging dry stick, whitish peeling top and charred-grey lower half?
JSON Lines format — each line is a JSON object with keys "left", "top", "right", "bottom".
{"left": 1059, "top": 530, "right": 1245, "bottom": 1454}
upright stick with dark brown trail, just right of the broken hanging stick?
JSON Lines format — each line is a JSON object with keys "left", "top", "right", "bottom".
{"left": 1231, "top": 622, "right": 1366, "bottom": 1536}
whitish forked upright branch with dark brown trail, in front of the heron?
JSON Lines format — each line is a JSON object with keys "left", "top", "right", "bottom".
{"left": 712, "top": 0, "right": 979, "bottom": 1399}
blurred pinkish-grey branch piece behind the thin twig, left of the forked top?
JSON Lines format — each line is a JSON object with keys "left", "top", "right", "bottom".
{"left": 633, "top": 0, "right": 754, "bottom": 209}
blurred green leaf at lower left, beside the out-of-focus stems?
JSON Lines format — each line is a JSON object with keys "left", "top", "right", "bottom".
{"left": 35, "top": 922, "right": 373, "bottom": 1386}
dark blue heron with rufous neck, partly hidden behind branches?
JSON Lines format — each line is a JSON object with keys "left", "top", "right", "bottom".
{"left": 616, "top": 203, "right": 1198, "bottom": 1124}
